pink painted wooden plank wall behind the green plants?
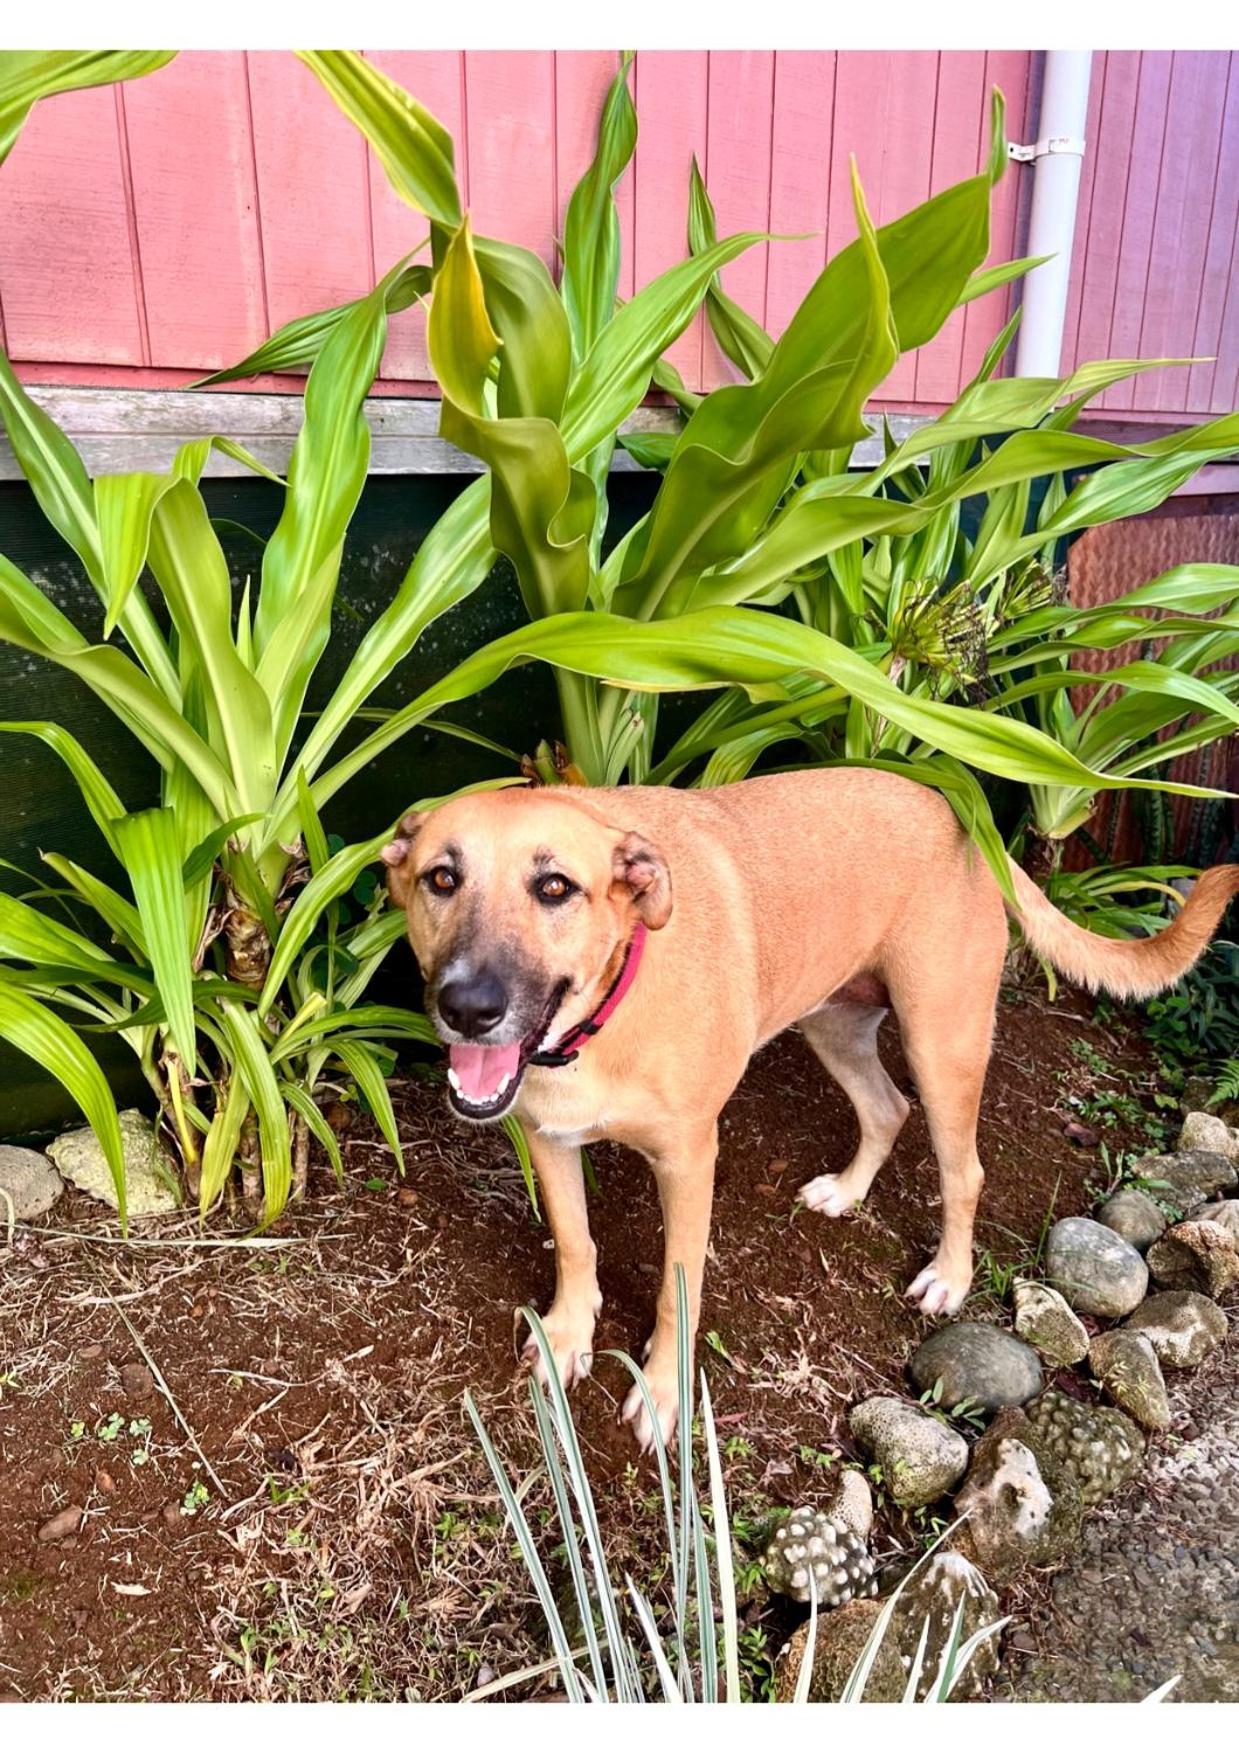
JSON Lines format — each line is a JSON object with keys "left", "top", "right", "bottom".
{"left": 0, "top": 51, "right": 1239, "bottom": 417}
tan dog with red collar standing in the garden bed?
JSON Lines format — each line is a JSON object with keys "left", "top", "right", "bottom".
{"left": 384, "top": 770, "right": 1239, "bottom": 1446}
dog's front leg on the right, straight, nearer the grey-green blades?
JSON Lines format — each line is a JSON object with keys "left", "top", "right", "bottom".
{"left": 624, "top": 1122, "right": 719, "bottom": 1450}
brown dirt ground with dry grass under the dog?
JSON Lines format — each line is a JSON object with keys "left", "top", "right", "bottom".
{"left": 0, "top": 983, "right": 1184, "bottom": 1700}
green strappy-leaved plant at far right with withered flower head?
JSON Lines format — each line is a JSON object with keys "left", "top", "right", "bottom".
{"left": 634, "top": 165, "right": 1239, "bottom": 869}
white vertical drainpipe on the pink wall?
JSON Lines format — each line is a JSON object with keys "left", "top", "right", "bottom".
{"left": 1015, "top": 49, "right": 1092, "bottom": 377}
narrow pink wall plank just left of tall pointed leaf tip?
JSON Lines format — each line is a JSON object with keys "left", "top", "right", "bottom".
{"left": 766, "top": 49, "right": 836, "bottom": 337}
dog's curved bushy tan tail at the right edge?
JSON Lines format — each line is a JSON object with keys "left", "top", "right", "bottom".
{"left": 1008, "top": 861, "right": 1239, "bottom": 997}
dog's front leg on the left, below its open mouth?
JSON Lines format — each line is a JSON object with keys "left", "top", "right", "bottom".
{"left": 524, "top": 1127, "right": 603, "bottom": 1388}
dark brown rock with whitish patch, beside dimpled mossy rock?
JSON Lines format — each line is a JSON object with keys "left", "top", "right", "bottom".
{"left": 955, "top": 1408, "right": 1081, "bottom": 1583}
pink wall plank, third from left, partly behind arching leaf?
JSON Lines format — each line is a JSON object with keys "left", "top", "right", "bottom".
{"left": 247, "top": 49, "right": 375, "bottom": 330}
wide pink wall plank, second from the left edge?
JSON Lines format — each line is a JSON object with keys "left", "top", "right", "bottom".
{"left": 124, "top": 49, "right": 270, "bottom": 368}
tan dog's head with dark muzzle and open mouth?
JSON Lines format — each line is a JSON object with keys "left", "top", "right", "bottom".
{"left": 382, "top": 789, "right": 671, "bottom": 1120}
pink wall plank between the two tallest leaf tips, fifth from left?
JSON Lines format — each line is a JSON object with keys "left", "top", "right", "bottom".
{"left": 464, "top": 49, "right": 556, "bottom": 266}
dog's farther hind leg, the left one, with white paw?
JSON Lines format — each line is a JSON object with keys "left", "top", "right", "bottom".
{"left": 799, "top": 1003, "right": 908, "bottom": 1217}
